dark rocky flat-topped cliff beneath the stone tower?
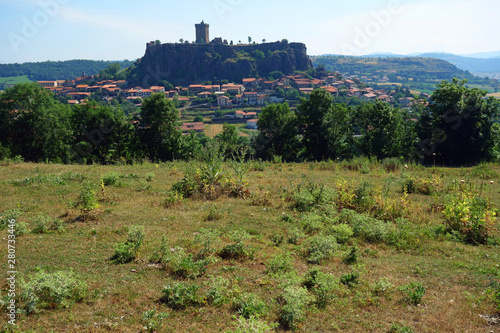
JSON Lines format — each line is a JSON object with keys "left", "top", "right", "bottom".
{"left": 129, "top": 41, "right": 312, "bottom": 86}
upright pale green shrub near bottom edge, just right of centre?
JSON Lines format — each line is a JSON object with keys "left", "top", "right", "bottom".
{"left": 280, "top": 286, "right": 314, "bottom": 329}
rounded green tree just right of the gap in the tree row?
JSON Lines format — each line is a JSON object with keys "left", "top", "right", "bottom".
{"left": 254, "top": 103, "right": 300, "bottom": 161}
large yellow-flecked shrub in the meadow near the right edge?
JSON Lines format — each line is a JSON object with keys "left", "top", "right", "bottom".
{"left": 443, "top": 192, "right": 496, "bottom": 244}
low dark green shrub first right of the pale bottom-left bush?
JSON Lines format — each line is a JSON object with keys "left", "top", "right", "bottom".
{"left": 160, "top": 282, "right": 203, "bottom": 310}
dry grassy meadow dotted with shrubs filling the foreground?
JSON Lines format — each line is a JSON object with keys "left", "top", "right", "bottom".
{"left": 0, "top": 159, "right": 500, "bottom": 332}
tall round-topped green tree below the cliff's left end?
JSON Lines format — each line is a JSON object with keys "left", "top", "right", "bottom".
{"left": 141, "top": 93, "right": 182, "bottom": 161}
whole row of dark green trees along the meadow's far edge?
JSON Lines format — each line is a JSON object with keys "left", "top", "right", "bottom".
{"left": 0, "top": 79, "right": 500, "bottom": 165}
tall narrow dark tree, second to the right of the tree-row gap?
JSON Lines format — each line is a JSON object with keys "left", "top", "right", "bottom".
{"left": 297, "top": 89, "right": 332, "bottom": 160}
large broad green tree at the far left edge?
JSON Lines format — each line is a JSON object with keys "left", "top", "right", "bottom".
{"left": 0, "top": 83, "right": 72, "bottom": 162}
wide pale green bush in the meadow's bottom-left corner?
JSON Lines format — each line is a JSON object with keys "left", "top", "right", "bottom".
{"left": 20, "top": 271, "right": 88, "bottom": 315}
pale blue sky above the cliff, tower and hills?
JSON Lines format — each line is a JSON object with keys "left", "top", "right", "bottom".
{"left": 0, "top": 0, "right": 500, "bottom": 63}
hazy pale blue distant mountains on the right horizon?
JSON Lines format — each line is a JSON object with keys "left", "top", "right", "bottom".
{"left": 322, "top": 51, "right": 500, "bottom": 76}
